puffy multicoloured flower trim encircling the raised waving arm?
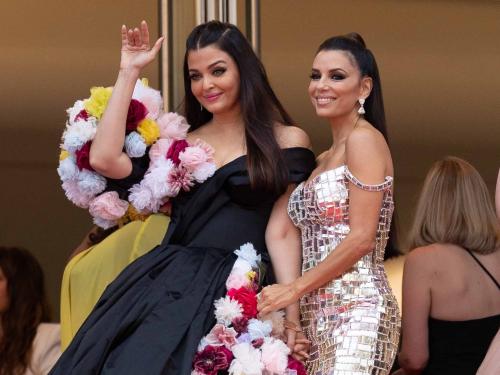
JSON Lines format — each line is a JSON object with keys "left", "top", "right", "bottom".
{"left": 57, "top": 79, "right": 215, "bottom": 229}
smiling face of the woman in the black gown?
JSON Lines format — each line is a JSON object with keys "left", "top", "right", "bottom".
{"left": 187, "top": 45, "right": 240, "bottom": 114}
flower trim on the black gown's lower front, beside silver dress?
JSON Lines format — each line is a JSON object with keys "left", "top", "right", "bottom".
{"left": 191, "top": 243, "right": 306, "bottom": 375}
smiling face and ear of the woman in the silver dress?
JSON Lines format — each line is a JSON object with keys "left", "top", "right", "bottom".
{"left": 309, "top": 50, "right": 371, "bottom": 118}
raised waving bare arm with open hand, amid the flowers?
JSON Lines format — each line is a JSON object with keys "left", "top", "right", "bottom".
{"left": 90, "top": 21, "right": 163, "bottom": 179}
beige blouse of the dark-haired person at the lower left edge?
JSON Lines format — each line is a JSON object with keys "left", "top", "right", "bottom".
{"left": 24, "top": 323, "right": 61, "bottom": 375}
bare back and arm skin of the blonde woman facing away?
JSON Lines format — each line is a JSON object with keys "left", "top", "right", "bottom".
{"left": 398, "top": 244, "right": 500, "bottom": 375}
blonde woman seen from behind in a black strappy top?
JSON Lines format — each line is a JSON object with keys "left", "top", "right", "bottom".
{"left": 399, "top": 157, "right": 500, "bottom": 375}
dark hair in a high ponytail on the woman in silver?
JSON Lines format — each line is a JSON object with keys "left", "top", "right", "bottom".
{"left": 317, "top": 33, "right": 387, "bottom": 140}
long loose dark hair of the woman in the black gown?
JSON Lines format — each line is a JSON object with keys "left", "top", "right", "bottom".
{"left": 184, "top": 21, "right": 292, "bottom": 193}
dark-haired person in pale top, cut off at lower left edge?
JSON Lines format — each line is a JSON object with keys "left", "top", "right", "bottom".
{"left": 0, "top": 246, "right": 60, "bottom": 375}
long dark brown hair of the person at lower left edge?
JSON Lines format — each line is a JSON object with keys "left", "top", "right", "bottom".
{"left": 0, "top": 247, "right": 50, "bottom": 375}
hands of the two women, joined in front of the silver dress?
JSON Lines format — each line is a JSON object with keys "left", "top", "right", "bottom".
{"left": 257, "top": 284, "right": 311, "bottom": 361}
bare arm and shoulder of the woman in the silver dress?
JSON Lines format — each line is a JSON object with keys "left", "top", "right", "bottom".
{"left": 260, "top": 129, "right": 388, "bottom": 313}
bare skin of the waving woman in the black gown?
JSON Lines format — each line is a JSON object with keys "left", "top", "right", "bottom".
{"left": 90, "top": 21, "right": 310, "bottom": 359}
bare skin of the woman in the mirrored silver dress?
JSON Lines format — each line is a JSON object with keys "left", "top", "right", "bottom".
{"left": 258, "top": 51, "right": 393, "bottom": 328}
